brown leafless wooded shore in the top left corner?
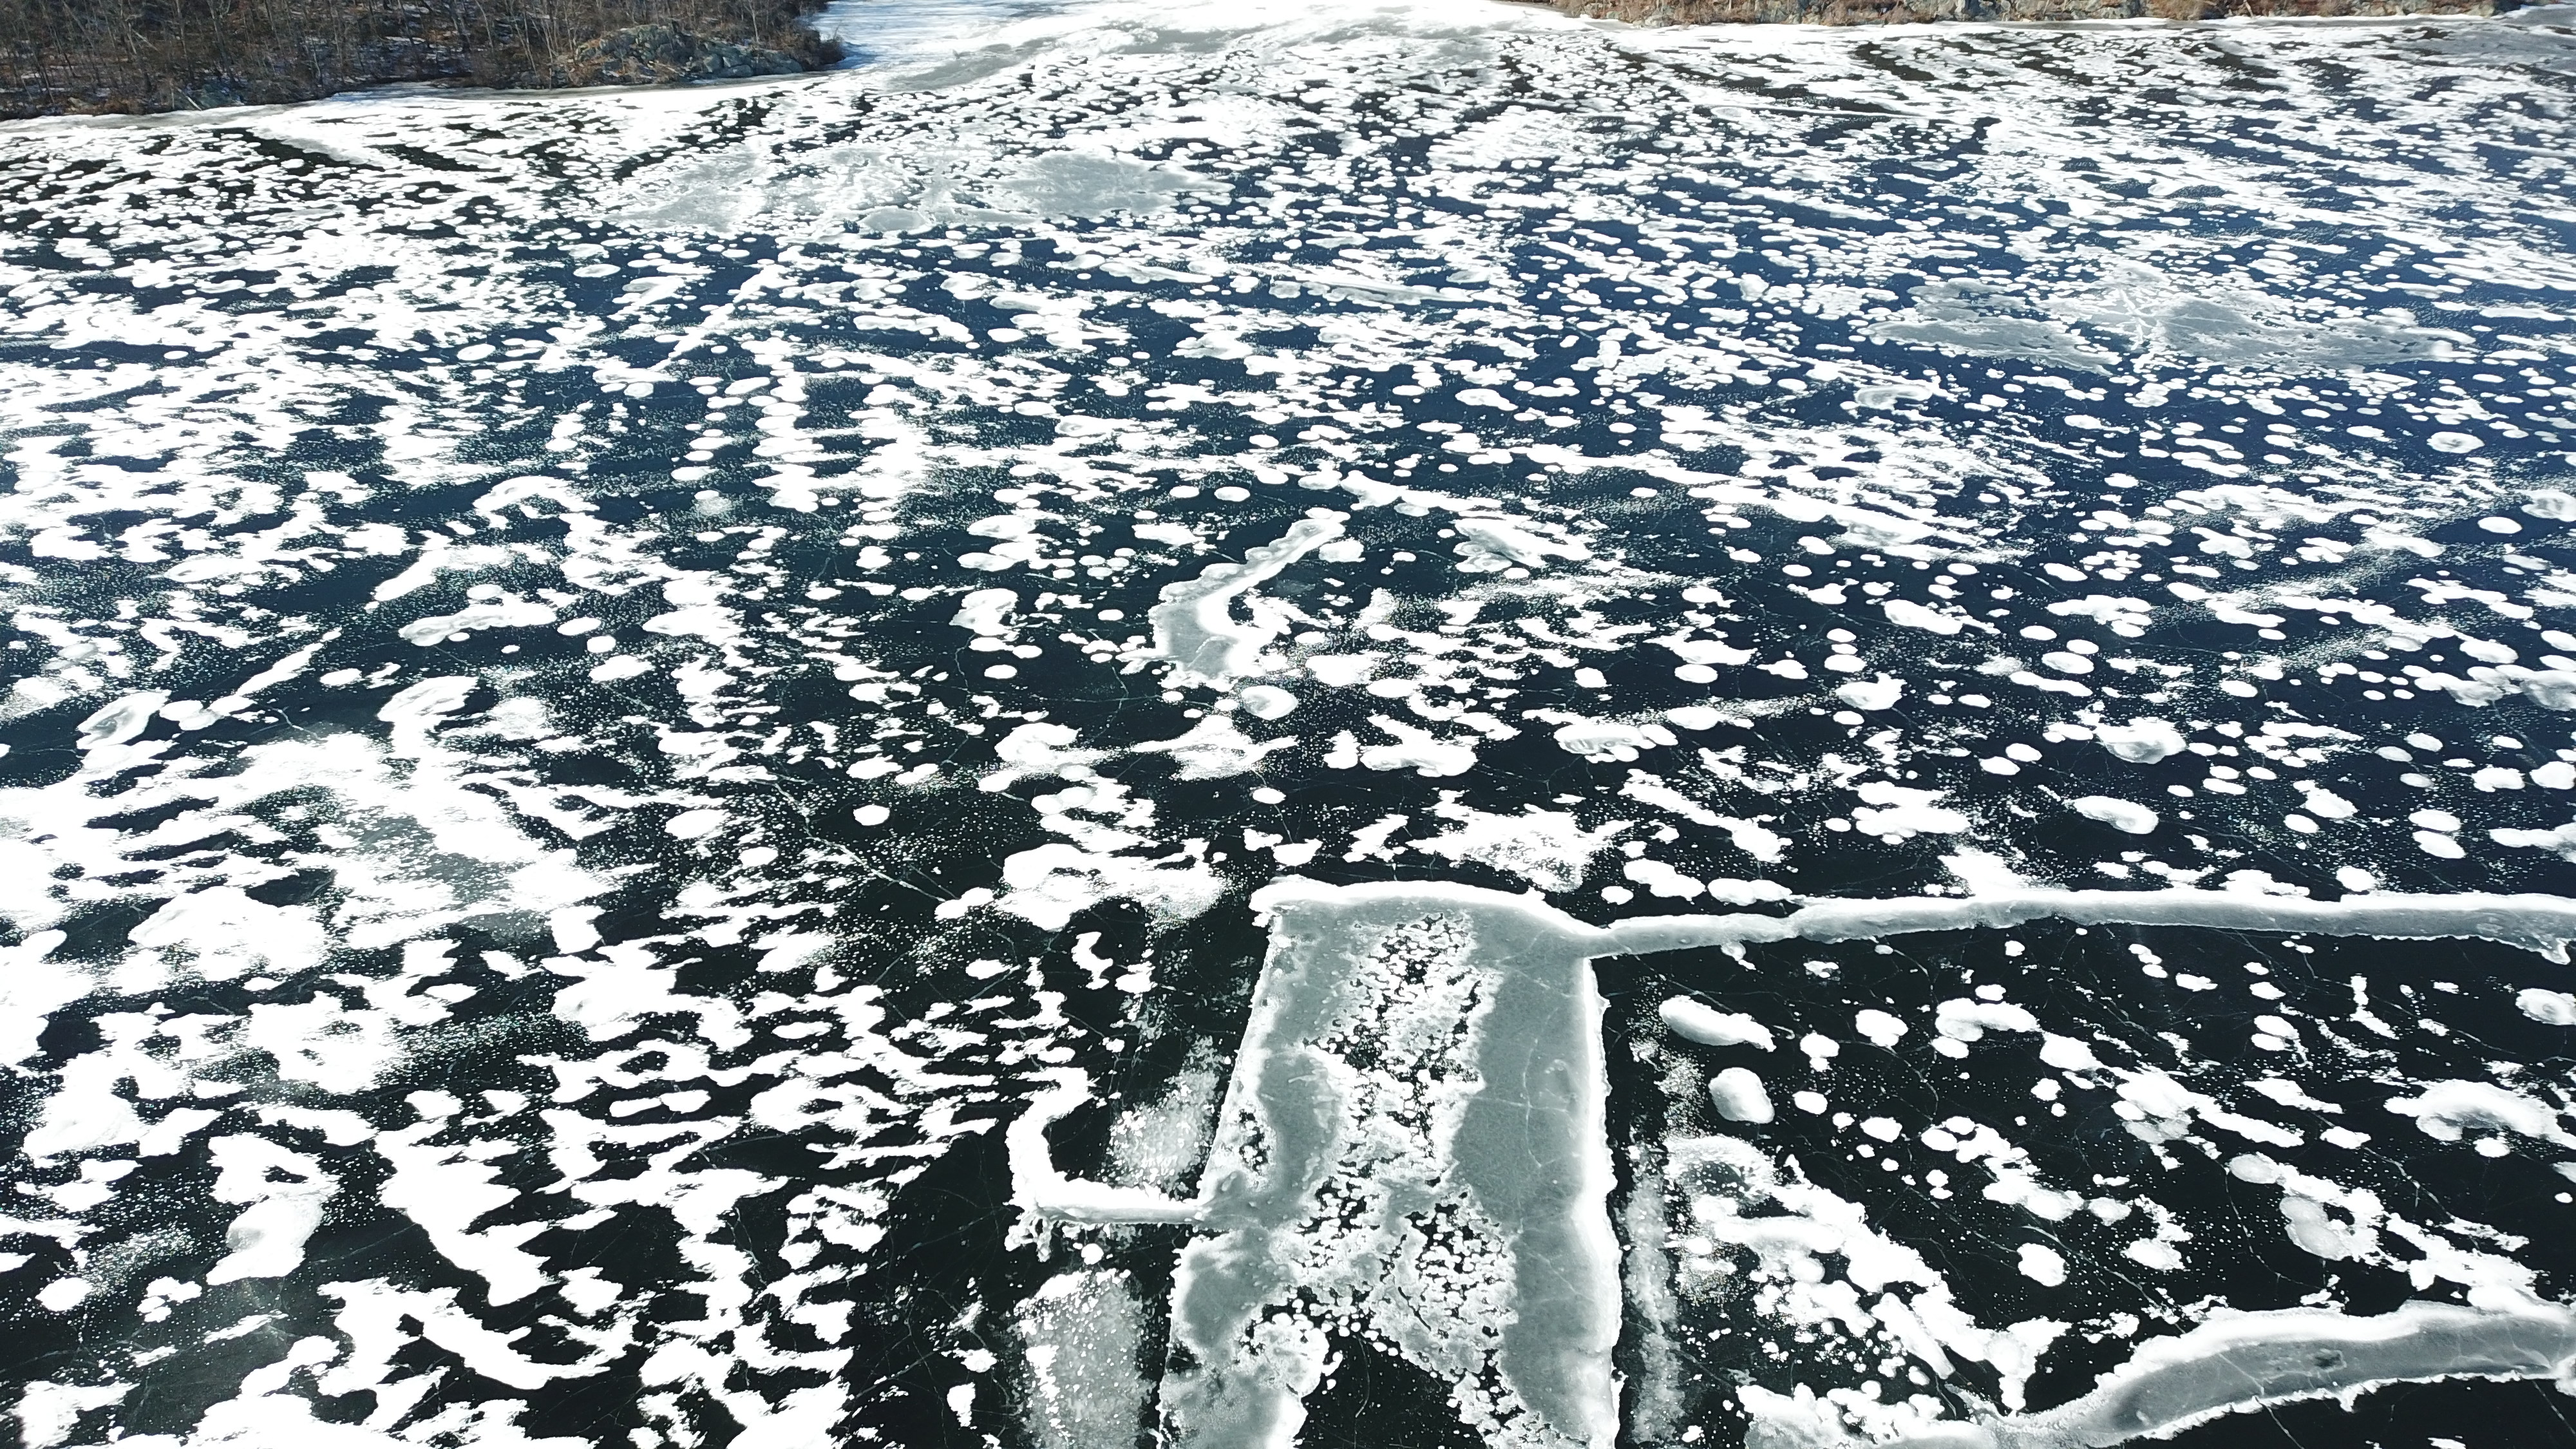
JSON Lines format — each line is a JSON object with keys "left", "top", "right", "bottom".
{"left": 0, "top": 0, "right": 837, "bottom": 116}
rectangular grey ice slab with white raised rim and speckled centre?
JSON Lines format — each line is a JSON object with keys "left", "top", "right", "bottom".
{"left": 1164, "top": 882, "right": 1620, "bottom": 1449}
